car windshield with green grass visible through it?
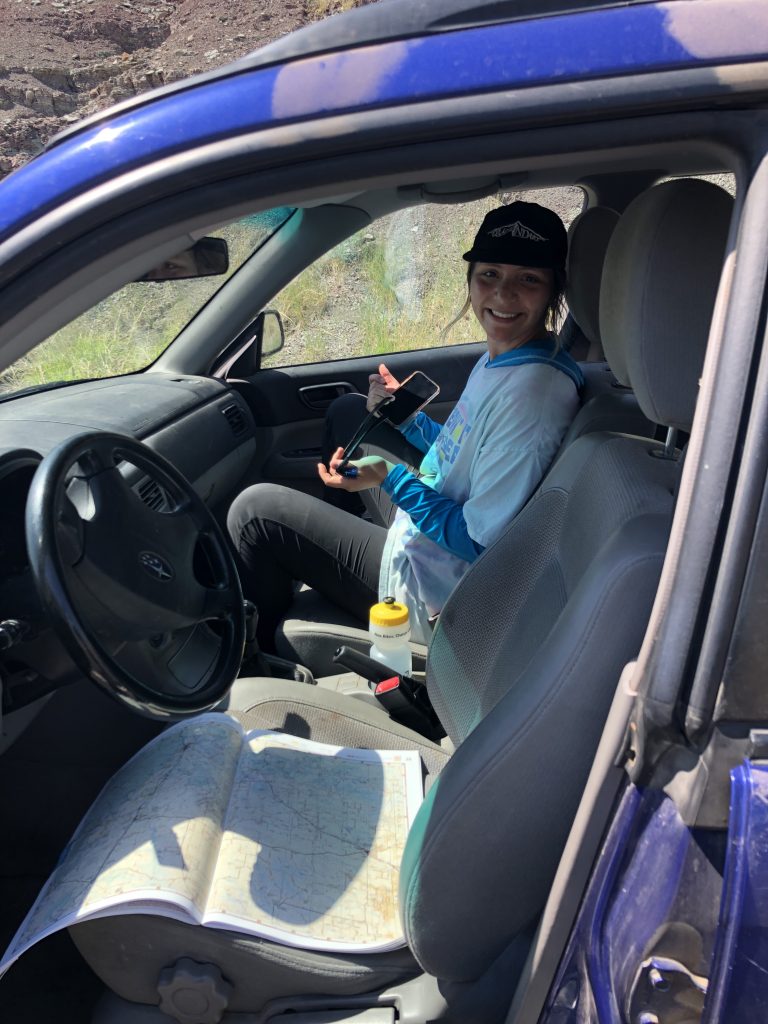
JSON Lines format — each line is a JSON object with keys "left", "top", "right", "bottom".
{"left": 0, "top": 207, "right": 294, "bottom": 395}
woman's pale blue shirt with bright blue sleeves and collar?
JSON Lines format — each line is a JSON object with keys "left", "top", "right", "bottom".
{"left": 380, "top": 343, "right": 581, "bottom": 639}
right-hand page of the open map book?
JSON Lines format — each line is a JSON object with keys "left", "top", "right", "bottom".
{"left": 206, "top": 733, "right": 423, "bottom": 950}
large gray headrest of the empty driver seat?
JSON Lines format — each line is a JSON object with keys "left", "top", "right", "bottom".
{"left": 600, "top": 178, "right": 733, "bottom": 430}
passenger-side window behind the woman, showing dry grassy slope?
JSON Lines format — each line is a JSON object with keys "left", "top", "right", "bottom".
{"left": 264, "top": 186, "right": 585, "bottom": 367}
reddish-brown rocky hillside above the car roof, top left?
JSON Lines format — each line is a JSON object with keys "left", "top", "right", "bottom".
{"left": 0, "top": 0, "right": 355, "bottom": 175}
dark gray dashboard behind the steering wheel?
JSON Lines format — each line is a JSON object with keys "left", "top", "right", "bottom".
{"left": 0, "top": 373, "right": 256, "bottom": 751}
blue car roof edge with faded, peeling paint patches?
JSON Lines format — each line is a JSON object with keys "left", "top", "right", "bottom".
{"left": 0, "top": 0, "right": 768, "bottom": 246}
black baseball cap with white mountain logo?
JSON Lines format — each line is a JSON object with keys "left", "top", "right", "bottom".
{"left": 464, "top": 201, "right": 568, "bottom": 270}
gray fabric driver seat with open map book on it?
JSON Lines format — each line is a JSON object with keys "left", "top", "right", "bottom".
{"left": 70, "top": 180, "right": 732, "bottom": 1024}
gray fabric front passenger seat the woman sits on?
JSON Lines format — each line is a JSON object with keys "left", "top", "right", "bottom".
{"left": 275, "top": 206, "right": 654, "bottom": 678}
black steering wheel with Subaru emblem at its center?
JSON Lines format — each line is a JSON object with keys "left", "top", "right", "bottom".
{"left": 27, "top": 431, "right": 245, "bottom": 720}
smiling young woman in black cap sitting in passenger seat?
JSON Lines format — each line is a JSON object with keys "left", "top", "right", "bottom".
{"left": 227, "top": 203, "right": 581, "bottom": 650}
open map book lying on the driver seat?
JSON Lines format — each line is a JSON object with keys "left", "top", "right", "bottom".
{"left": 0, "top": 714, "right": 423, "bottom": 974}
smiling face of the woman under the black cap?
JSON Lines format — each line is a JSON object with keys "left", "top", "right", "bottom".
{"left": 469, "top": 263, "right": 554, "bottom": 358}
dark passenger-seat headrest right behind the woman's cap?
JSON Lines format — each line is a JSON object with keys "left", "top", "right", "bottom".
{"left": 565, "top": 206, "right": 618, "bottom": 361}
